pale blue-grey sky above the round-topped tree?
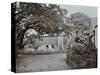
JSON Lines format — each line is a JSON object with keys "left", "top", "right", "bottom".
{"left": 60, "top": 5, "right": 97, "bottom": 17}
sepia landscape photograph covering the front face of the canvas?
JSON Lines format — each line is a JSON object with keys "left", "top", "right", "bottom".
{"left": 11, "top": 2, "right": 98, "bottom": 73}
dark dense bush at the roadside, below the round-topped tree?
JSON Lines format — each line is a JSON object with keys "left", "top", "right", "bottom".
{"left": 67, "top": 43, "right": 97, "bottom": 68}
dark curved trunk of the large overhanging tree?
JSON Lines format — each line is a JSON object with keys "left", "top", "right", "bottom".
{"left": 16, "top": 29, "right": 27, "bottom": 49}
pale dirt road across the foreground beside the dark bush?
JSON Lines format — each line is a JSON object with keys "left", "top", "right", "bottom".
{"left": 16, "top": 53, "right": 71, "bottom": 72}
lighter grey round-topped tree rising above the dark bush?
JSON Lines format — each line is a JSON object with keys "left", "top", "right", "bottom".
{"left": 71, "top": 12, "right": 91, "bottom": 45}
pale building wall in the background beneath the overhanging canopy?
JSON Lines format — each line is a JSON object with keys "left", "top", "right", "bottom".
{"left": 40, "top": 36, "right": 67, "bottom": 50}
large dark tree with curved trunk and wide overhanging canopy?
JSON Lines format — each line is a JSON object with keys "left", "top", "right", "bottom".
{"left": 14, "top": 2, "right": 67, "bottom": 48}
